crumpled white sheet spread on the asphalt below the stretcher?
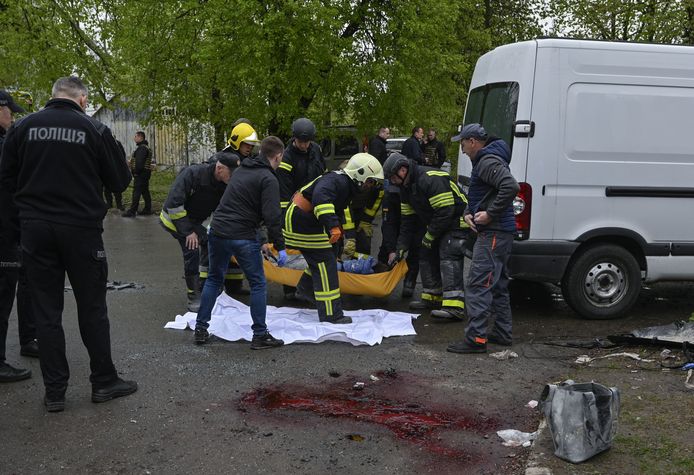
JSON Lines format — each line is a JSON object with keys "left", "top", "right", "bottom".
{"left": 164, "top": 293, "right": 417, "bottom": 346}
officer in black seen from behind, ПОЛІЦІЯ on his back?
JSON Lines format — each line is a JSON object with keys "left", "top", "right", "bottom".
{"left": 0, "top": 77, "right": 137, "bottom": 412}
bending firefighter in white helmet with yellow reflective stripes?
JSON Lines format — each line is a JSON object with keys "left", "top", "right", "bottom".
{"left": 282, "top": 153, "right": 383, "bottom": 323}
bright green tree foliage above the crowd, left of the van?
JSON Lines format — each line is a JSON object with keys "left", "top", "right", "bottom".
{"left": 0, "top": 0, "right": 544, "bottom": 146}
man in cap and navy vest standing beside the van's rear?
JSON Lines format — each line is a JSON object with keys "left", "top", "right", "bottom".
{"left": 447, "top": 124, "right": 519, "bottom": 353}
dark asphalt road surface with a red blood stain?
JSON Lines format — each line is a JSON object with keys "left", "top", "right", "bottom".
{"left": 0, "top": 214, "right": 694, "bottom": 473}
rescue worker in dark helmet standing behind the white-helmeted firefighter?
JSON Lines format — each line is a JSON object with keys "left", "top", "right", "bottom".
{"left": 277, "top": 117, "right": 326, "bottom": 300}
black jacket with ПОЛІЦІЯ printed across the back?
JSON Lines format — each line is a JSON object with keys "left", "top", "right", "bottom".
{"left": 0, "top": 99, "right": 131, "bottom": 229}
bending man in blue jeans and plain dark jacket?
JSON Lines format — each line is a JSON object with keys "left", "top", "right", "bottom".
{"left": 194, "top": 136, "right": 287, "bottom": 350}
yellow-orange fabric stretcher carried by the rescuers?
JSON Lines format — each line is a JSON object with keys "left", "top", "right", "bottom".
{"left": 263, "top": 260, "right": 407, "bottom": 297}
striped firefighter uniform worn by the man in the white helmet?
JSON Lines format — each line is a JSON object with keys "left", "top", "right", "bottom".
{"left": 282, "top": 171, "right": 357, "bottom": 321}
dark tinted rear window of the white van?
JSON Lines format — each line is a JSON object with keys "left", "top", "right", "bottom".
{"left": 465, "top": 82, "right": 520, "bottom": 149}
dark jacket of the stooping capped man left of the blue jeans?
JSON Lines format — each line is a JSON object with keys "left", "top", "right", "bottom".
{"left": 159, "top": 161, "right": 226, "bottom": 239}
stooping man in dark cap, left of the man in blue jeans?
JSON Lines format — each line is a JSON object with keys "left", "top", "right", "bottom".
{"left": 159, "top": 152, "right": 240, "bottom": 312}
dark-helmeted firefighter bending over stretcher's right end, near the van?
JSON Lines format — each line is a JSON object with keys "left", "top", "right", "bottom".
{"left": 383, "top": 153, "right": 469, "bottom": 321}
